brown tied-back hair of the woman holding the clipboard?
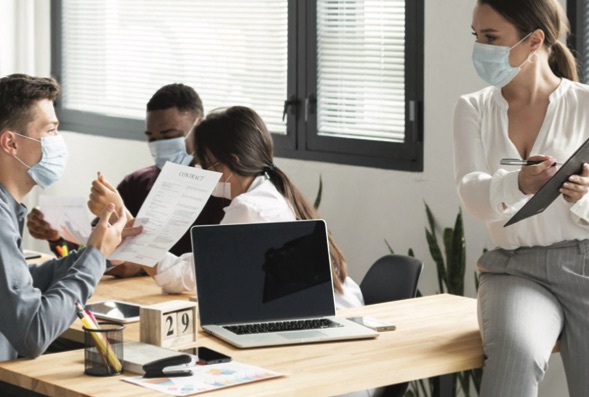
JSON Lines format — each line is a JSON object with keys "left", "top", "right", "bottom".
{"left": 479, "top": 0, "right": 579, "bottom": 81}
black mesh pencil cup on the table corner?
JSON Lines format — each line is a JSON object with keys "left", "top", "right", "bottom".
{"left": 82, "top": 322, "right": 125, "bottom": 376}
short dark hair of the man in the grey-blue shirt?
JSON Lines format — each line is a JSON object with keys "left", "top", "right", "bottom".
{"left": 0, "top": 74, "right": 59, "bottom": 134}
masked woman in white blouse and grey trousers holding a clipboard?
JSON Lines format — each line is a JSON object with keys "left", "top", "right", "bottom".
{"left": 454, "top": 0, "right": 589, "bottom": 397}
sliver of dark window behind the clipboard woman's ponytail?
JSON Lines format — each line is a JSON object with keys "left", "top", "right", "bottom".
{"left": 567, "top": 0, "right": 589, "bottom": 83}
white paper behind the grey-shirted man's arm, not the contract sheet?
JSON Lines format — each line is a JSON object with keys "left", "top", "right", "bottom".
{"left": 39, "top": 195, "right": 93, "bottom": 244}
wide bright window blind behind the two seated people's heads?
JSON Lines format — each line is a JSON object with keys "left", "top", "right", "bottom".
{"left": 60, "top": 0, "right": 288, "bottom": 134}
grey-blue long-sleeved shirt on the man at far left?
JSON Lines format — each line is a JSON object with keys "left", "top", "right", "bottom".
{"left": 0, "top": 184, "right": 105, "bottom": 361}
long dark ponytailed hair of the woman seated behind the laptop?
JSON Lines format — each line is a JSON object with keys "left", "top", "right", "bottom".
{"left": 192, "top": 106, "right": 347, "bottom": 292}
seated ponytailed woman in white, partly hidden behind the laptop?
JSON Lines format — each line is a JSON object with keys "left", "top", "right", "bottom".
{"left": 149, "top": 106, "right": 364, "bottom": 309}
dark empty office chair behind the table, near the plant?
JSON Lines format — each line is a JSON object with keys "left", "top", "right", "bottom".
{"left": 360, "top": 255, "right": 423, "bottom": 397}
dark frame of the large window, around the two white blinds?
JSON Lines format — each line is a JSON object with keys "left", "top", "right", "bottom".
{"left": 51, "top": 0, "right": 425, "bottom": 172}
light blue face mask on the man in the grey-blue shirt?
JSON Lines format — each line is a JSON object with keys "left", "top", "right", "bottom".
{"left": 14, "top": 133, "right": 68, "bottom": 189}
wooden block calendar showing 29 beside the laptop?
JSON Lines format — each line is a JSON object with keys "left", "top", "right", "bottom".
{"left": 139, "top": 300, "right": 197, "bottom": 347}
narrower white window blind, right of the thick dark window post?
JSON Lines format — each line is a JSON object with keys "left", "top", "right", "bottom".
{"left": 317, "top": 0, "right": 405, "bottom": 142}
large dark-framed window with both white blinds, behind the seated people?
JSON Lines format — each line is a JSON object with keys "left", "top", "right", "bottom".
{"left": 52, "top": 0, "right": 423, "bottom": 171}
